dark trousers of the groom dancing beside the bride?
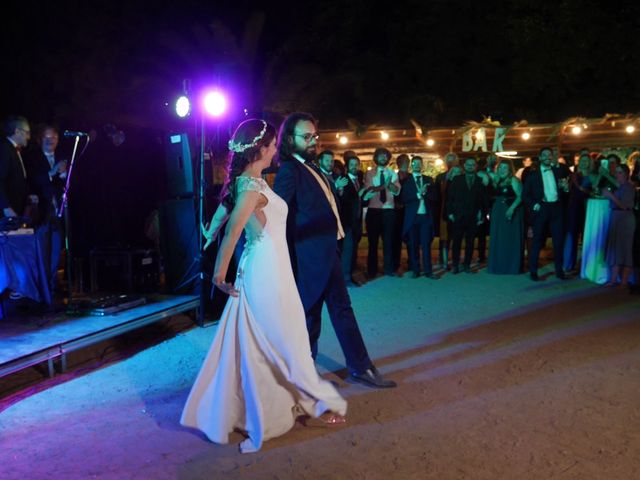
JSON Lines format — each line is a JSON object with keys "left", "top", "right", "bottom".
{"left": 305, "top": 253, "right": 373, "bottom": 373}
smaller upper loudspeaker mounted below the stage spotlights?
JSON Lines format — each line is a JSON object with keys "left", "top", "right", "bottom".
{"left": 165, "top": 133, "right": 193, "bottom": 198}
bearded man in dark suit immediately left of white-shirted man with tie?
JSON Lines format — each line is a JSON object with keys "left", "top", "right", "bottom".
{"left": 339, "top": 155, "right": 364, "bottom": 287}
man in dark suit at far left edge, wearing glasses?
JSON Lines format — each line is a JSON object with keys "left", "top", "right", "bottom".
{"left": 0, "top": 117, "right": 35, "bottom": 217}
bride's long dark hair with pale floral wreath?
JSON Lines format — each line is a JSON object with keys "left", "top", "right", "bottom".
{"left": 220, "top": 118, "right": 276, "bottom": 211}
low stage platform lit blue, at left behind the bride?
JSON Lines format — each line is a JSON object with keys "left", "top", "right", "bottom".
{"left": 0, "top": 294, "right": 200, "bottom": 377}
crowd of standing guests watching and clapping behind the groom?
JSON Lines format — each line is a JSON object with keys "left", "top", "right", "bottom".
{"left": 318, "top": 147, "right": 640, "bottom": 288}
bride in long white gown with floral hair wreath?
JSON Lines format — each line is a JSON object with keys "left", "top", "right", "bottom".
{"left": 180, "top": 119, "right": 347, "bottom": 453}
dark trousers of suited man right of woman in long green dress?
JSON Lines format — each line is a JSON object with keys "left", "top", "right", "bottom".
{"left": 529, "top": 201, "right": 564, "bottom": 274}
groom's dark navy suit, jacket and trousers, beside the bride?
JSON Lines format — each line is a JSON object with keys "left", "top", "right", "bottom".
{"left": 273, "top": 157, "right": 373, "bottom": 373}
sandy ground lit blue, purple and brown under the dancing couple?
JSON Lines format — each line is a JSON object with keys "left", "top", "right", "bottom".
{"left": 0, "top": 260, "right": 640, "bottom": 480}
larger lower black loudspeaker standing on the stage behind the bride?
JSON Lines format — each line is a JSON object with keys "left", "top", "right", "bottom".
{"left": 159, "top": 198, "right": 201, "bottom": 294}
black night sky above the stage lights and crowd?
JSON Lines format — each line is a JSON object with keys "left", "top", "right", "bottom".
{"left": 0, "top": 0, "right": 640, "bottom": 128}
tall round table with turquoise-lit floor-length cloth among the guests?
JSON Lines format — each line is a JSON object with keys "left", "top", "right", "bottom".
{"left": 580, "top": 198, "right": 611, "bottom": 284}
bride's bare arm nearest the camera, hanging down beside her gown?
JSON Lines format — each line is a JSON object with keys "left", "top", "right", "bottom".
{"left": 213, "top": 190, "right": 264, "bottom": 297}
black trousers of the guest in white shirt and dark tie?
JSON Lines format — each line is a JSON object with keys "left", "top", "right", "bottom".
{"left": 365, "top": 208, "right": 396, "bottom": 277}
